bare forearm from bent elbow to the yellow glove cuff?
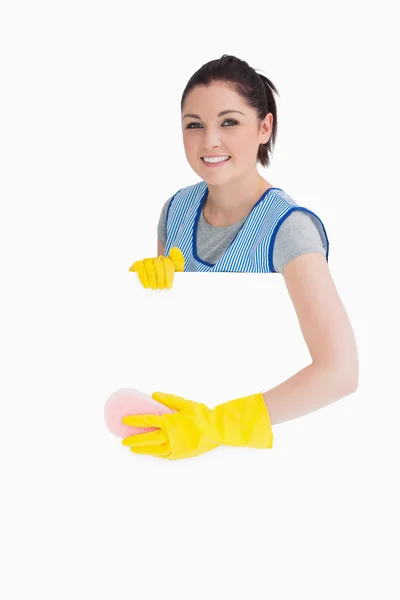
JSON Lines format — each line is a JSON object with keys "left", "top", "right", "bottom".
{"left": 262, "top": 363, "right": 357, "bottom": 425}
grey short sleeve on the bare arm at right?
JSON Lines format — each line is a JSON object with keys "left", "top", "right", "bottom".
{"left": 272, "top": 210, "right": 327, "bottom": 273}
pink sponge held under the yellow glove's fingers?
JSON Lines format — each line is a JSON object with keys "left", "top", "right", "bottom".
{"left": 104, "top": 388, "right": 175, "bottom": 438}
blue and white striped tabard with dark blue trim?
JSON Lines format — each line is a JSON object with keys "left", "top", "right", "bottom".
{"left": 165, "top": 181, "right": 329, "bottom": 273}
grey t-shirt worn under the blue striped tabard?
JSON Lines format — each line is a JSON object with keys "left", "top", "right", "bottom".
{"left": 158, "top": 196, "right": 327, "bottom": 273}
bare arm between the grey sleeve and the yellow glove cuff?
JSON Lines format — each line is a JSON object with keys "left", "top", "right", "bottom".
{"left": 263, "top": 253, "right": 358, "bottom": 425}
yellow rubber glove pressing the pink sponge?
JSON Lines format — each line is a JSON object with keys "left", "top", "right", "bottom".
{"left": 122, "top": 392, "right": 273, "bottom": 460}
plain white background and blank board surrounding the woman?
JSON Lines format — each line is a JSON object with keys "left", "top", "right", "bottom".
{"left": 0, "top": 0, "right": 400, "bottom": 600}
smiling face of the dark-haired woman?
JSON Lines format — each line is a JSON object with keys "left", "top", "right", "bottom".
{"left": 182, "top": 82, "right": 272, "bottom": 182}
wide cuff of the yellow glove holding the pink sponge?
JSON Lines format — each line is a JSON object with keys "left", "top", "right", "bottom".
{"left": 210, "top": 392, "right": 274, "bottom": 448}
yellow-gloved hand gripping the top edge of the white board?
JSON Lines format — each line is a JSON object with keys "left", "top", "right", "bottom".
{"left": 129, "top": 247, "right": 185, "bottom": 290}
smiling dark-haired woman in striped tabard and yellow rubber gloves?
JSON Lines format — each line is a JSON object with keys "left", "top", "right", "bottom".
{"left": 123, "top": 55, "right": 358, "bottom": 459}
